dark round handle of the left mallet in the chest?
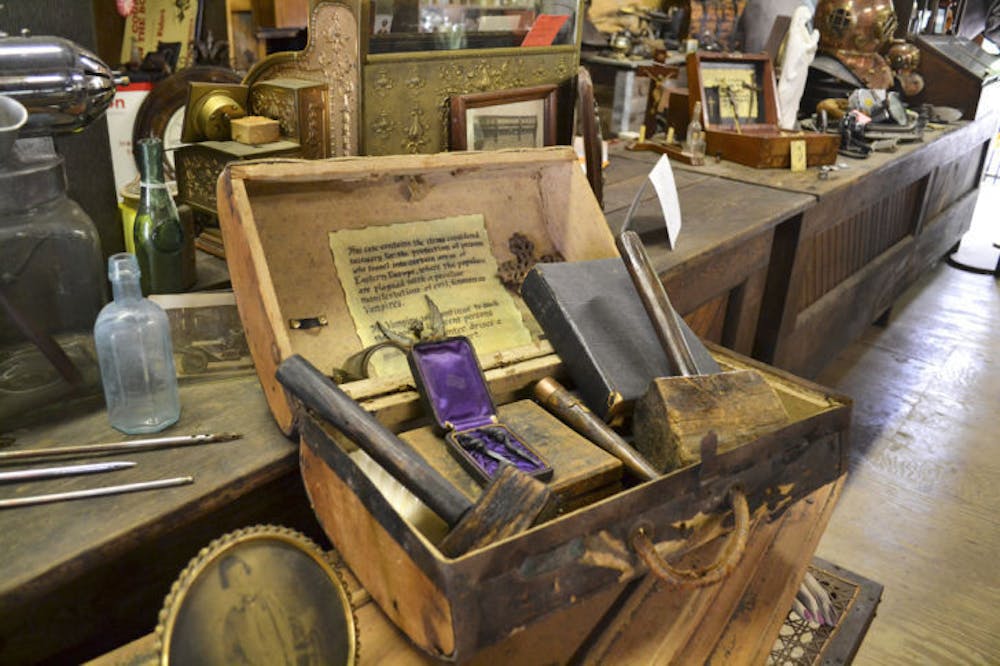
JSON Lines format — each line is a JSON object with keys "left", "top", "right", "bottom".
{"left": 276, "top": 354, "right": 472, "bottom": 526}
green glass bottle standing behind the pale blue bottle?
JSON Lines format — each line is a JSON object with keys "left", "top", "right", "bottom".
{"left": 132, "top": 138, "right": 185, "bottom": 295}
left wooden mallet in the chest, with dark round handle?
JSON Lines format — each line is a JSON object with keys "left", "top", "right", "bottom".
{"left": 276, "top": 355, "right": 555, "bottom": 557}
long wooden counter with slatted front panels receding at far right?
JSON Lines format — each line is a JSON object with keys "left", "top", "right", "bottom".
{"left": 664, "top": 115, "right": 997, "bottom": 377}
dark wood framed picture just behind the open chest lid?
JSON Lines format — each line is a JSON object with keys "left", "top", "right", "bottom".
{"left": 449, "top": 85, "right": 557, "bottom": 150}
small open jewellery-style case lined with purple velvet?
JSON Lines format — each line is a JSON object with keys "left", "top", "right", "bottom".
{"left": 409, "top": 337, "right": 552, "bottom": 483}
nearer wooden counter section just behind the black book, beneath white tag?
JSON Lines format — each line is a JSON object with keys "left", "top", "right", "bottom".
{"left": 604, "top": 148, "right": 815, "bottom": 355}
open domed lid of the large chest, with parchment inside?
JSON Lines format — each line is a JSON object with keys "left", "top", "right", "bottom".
{"left": 218, "top": 148, "right": 617, "bottom": 433}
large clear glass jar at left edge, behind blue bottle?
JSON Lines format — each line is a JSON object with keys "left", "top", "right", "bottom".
{"left": 0, "top": 139, "right": 106, "bottom": 431}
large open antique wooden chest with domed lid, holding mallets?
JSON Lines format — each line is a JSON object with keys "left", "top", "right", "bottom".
{"left": 219, "top": 148, "right": 850, "bottom": 662}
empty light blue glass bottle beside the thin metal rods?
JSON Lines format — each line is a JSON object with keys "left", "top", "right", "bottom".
{"left": 94, "top": 253, "right": 181, "bottom": 435}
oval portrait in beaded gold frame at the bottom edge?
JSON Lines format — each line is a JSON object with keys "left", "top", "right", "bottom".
{"left": 156, "top": 525, "right": 359, "bottom": 666}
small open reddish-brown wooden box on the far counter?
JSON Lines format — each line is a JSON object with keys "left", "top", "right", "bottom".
{"left": 687, "top": 51, "right": 840, "bottom": 168}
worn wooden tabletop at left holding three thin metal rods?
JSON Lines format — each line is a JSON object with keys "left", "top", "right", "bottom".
{"left": 0, "top": 375, "right": 322, "bottom": 663}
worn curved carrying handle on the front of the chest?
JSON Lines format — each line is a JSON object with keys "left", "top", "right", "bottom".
{"left": 631, "top": 488, "right": 750, "bottom": 587}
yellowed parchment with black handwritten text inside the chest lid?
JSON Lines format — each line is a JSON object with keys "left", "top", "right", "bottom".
{"left": 330, "top": 215, "right": 531, "bottom": 376}
